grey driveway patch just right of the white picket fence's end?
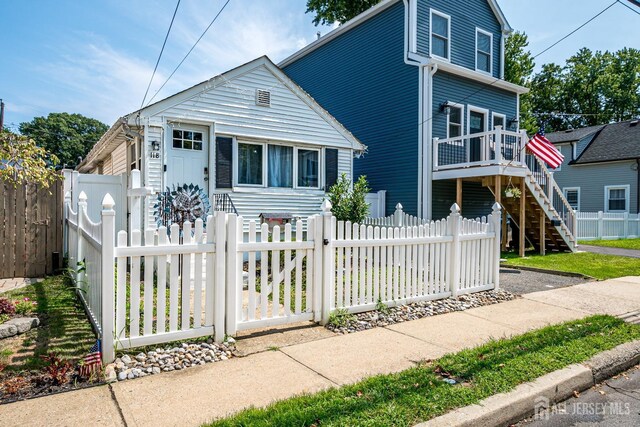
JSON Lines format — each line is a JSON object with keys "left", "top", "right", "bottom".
{"left": 500, "top": 267, "right": 588, "bottom": 295}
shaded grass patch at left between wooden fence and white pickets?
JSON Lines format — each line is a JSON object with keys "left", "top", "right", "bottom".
{"left": 0, "top": 276, "right": 96, "bottom": 371}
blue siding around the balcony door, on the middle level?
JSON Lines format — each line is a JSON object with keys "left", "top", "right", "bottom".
{"left": 432, "top": 71, "right": 518, "bottom": 138}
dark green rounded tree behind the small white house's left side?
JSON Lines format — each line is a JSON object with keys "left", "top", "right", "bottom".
{"left": 20, "top": 113, "right": 109, "bottom": 165}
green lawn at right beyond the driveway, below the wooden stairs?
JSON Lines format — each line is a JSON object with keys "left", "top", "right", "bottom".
{"left": 502, "top": 252, "right": 640, "bottom": 280}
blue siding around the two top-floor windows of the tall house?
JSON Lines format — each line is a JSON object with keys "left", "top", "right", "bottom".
{"left": 417, "top": 0, "right": 502, "bottom": 77}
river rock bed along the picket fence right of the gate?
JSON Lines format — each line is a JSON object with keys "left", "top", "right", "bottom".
{"left": 326, "top": 289, "right": 519, "bottom": 334}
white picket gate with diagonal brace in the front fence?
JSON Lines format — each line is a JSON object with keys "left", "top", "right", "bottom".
{"left": 226, "top": 214, "right": 322, "bottom": 335}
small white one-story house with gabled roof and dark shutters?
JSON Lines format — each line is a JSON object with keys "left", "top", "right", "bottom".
{"left": 78, "top": 56, "right": 365, "bottom": 231}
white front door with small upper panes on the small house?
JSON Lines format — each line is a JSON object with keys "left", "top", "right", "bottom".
{"left": 165, "top": 124, "right": 209, "bottom": 193}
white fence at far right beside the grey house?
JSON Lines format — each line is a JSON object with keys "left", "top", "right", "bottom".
{"left": 576, "top": 211, "right": 640, "bottom": 240}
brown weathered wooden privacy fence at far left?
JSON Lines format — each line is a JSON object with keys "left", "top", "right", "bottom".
{"left": 0, "top": 181, "right": 62, "bottom": 279}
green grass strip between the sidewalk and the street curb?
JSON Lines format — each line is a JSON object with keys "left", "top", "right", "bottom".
{"left": 210, "top": 316, "right": 640, "bottom": 427}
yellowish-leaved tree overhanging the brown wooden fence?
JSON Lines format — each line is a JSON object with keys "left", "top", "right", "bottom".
{"left": 0, "top": 131, "right": 62, "bottom": 188}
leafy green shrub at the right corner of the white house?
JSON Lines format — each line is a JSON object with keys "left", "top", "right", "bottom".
{"left": 329, "top": 173, "right": 370, "bottom": 222}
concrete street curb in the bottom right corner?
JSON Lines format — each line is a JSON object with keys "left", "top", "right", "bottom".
{"left": 414, "top": 340, "right": 640, "bottom": 427}
